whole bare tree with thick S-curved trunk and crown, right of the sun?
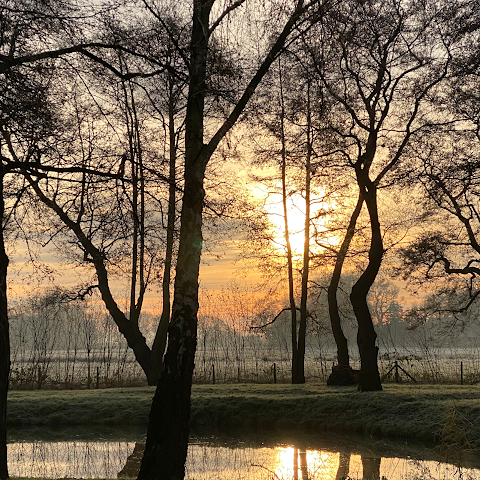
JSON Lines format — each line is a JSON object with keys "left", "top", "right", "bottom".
{"left": 304, "top": 1, "right": 462, "bottom": 390}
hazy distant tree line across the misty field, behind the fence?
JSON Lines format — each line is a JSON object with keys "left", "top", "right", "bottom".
{"left": 9, "top": 279, "right": 480, "bottom": 389}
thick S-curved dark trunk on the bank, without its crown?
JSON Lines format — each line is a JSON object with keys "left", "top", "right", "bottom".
{"left": 350, "top": 168, "right": 384, "bottom": 391}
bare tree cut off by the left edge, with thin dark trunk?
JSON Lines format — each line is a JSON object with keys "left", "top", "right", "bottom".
{"left": 0, "top": 0, "right": 170, "bottom": 472}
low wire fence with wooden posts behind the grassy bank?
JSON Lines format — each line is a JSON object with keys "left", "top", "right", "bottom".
{"left": 10, "top": 344, "right": 480, "bottom": 389}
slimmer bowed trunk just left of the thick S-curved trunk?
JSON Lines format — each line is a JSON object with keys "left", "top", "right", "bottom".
{"left": 327, "top": 195, "right": 363, "bottom": 367}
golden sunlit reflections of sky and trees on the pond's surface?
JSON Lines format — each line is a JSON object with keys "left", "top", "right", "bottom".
{"left": 8, "top": 439, "right": 480, "bottom": 480}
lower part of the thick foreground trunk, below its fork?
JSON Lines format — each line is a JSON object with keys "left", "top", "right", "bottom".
{"left": 138, "top": 165, "right": 204, "bottom": 480}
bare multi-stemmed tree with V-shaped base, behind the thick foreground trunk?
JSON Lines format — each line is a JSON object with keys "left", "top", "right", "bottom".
{"left": 10, "top": 9, "right": 251, "bottom": 384}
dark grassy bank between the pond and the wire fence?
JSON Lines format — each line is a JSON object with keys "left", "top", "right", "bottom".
{"left": 7, "top": 384, "right": 480, "bottom": 448}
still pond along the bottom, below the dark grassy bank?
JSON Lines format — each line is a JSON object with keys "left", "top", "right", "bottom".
{"left": 8, "top": 429, "right": 480, "bottom": 480}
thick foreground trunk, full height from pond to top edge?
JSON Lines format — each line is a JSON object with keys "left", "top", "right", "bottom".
{"left": 138, "top": 0, "right": 212, "bottom": 480}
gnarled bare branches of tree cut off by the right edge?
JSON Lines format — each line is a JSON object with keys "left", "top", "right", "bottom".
{"left": 400, "top": 15, "right": 480, "bottom": 304}
